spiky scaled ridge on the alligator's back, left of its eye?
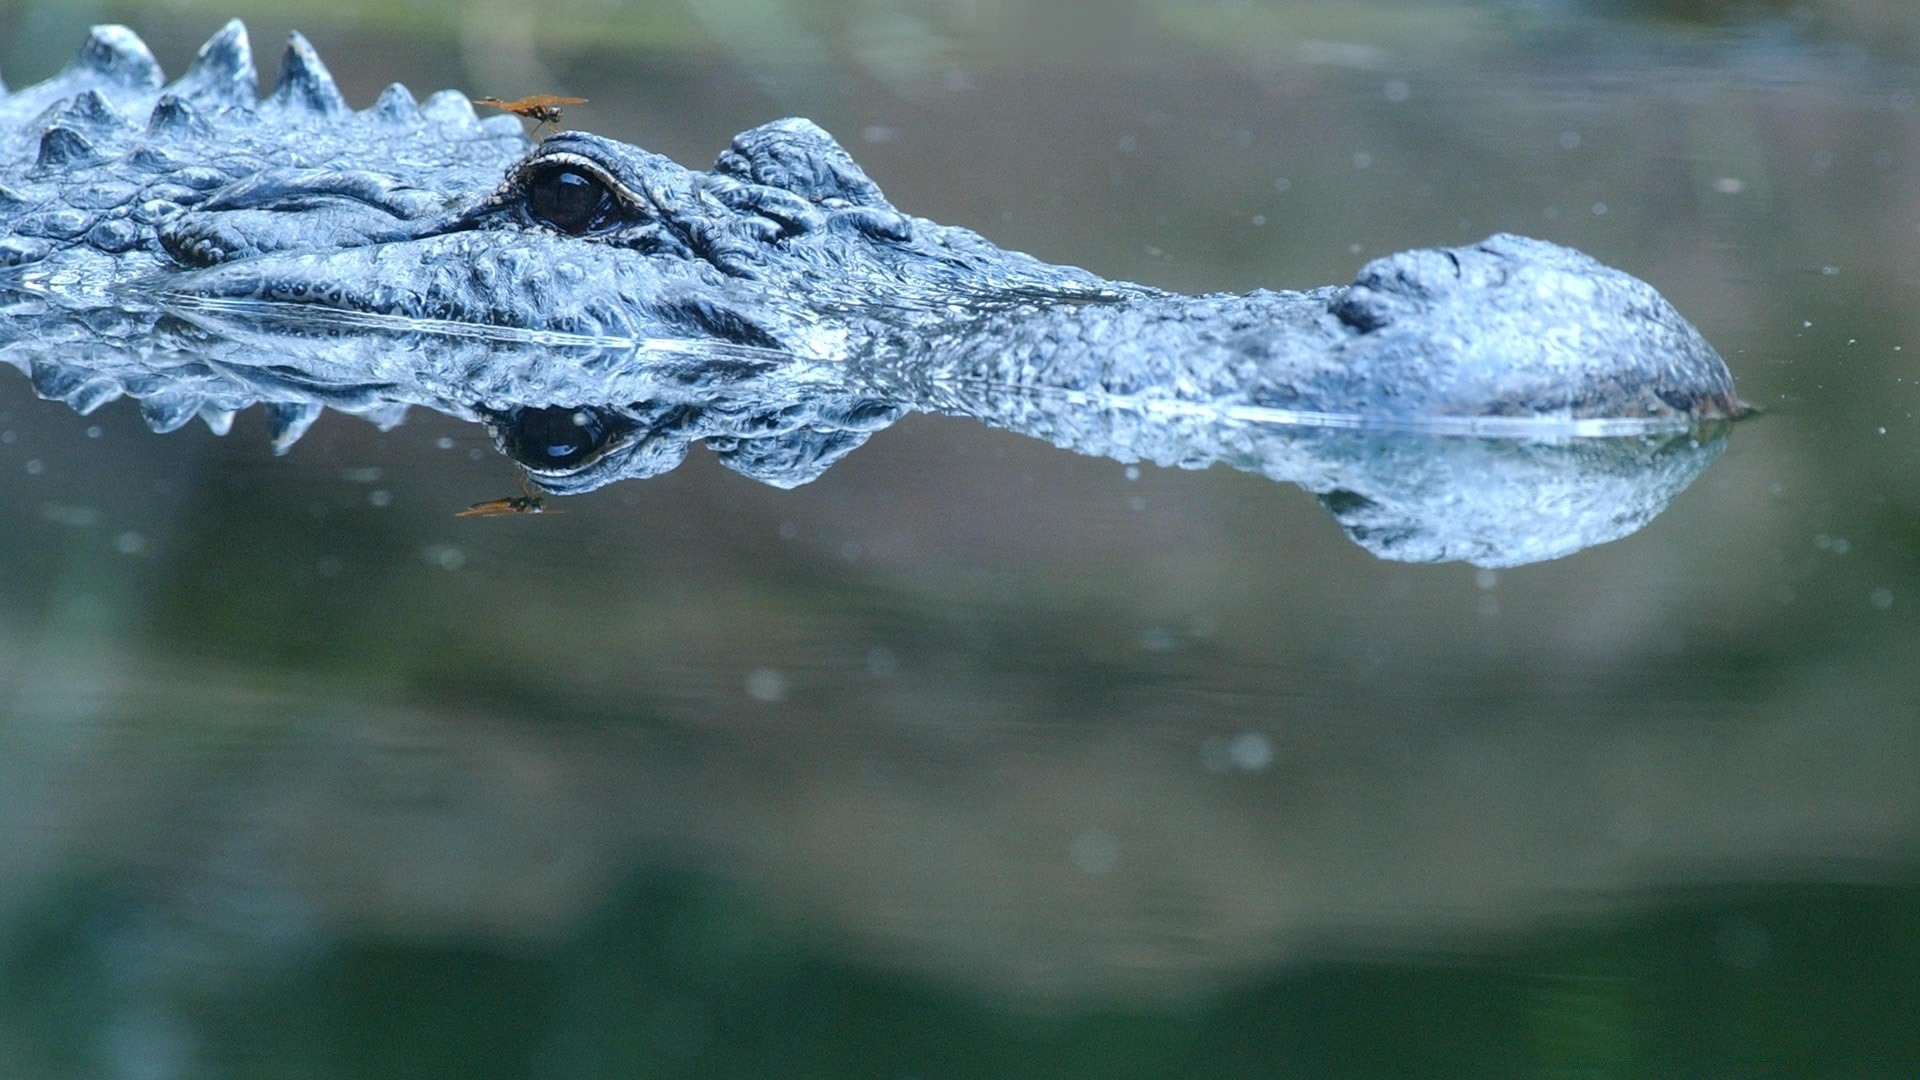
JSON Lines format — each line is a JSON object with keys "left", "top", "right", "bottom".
{"left": 0, "top": 19, "right": 528, "bottom": 279}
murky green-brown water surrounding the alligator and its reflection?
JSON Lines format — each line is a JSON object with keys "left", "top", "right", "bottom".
{"left": 0, "top": 0, "right": 1920, "bottom": 1078}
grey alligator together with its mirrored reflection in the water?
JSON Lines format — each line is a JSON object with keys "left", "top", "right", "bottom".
{"left": 0, "top": 21, "right": 1745, "bottom": 565}
